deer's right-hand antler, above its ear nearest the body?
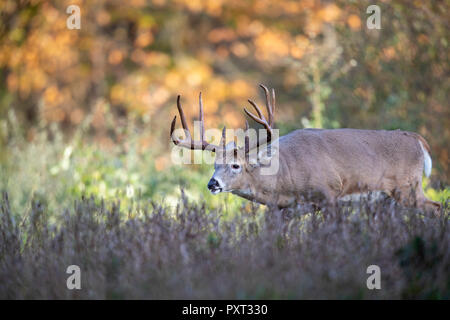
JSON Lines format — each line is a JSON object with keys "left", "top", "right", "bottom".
{"left": 244, "top": 84, "right": 275, "bottom": 153}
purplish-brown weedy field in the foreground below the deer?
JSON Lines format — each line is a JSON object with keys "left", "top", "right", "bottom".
{"left": 0, "top": 193, "right": 450, "bottom": 299}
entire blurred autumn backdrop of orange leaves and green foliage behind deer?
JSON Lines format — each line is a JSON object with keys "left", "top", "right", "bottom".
{"left": 0, "top": 0, "right": 450, "bottom": 215}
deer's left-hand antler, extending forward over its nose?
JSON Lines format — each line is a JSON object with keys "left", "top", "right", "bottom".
{"left": 170, "top": 92, "right": 225, "bottom": 152}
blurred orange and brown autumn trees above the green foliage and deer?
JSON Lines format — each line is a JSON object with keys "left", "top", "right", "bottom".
{"left": 0, "top": 0, "right": 450, "bottom": 181}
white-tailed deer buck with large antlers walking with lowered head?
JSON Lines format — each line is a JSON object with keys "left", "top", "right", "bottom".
{"left": 170, "top": 85, "right": 440, "bottom": 208}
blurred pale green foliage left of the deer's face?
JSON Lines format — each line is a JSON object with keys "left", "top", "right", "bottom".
{"left": 0, "top": 114, "right": 248, "bottom": 215}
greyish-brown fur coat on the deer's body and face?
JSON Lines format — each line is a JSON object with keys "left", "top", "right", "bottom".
{"left": 213, "top": 129, "right": 439, "bottom": 208}
